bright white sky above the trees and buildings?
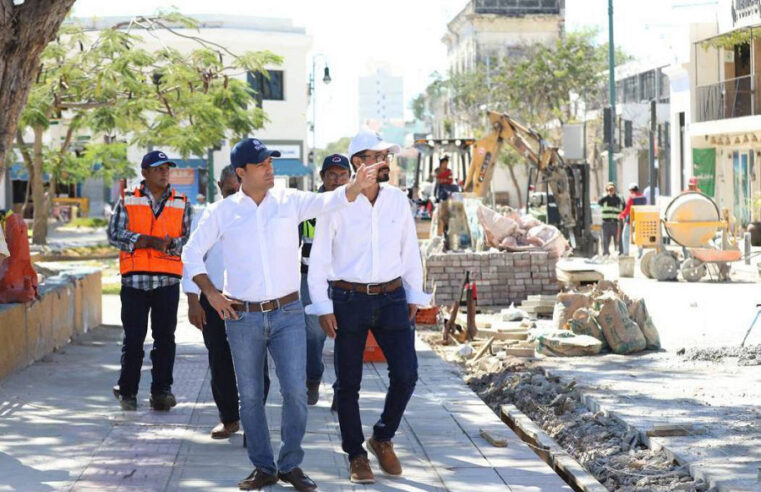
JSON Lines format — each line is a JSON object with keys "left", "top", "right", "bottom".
{"left": 73, "top": 0, "right": 717, "bottom": 146}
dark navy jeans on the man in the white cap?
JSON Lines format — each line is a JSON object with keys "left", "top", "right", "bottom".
{"left": 330, "top": 287, "right": 417, "bottom": 459}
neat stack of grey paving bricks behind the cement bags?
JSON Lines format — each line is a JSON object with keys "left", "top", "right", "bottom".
{"left": 425, "top": 251, "right": 559, "bottom": 306}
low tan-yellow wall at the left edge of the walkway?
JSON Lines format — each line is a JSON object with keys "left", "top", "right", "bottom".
{"left": 0, "top": 270, "right": 102, "bottom": 379}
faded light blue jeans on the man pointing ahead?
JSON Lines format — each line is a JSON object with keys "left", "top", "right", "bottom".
{"left": 225, "top": 301, "right": 307, "bottom": 474}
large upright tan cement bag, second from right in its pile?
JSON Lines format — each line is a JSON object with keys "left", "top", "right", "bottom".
{"left": 597, "top": 292, "right": 647, "bottom": 354}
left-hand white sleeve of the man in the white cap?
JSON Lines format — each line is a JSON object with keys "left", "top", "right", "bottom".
{"left": 306, "top": 215, "right": 334, "bottom": 316}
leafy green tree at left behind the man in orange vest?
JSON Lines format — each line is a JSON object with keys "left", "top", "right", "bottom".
{"left": 18, "top": 12, "right": 281, "bottom": 244}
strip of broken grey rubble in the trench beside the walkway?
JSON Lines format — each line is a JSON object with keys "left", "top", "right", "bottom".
{"left": 427, "top": 335, "right": 708, "bottom": 492}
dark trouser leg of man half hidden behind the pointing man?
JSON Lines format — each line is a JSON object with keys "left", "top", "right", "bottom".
{"left": 201, "top": 294, "right": 240, "bottom": 424}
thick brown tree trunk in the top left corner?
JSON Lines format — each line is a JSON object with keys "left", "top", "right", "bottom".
{"left": 0, "top": 0, "right": 74, "bottom": 169}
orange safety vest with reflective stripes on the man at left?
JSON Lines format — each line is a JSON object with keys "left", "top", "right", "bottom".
{"left": 119, "top": 188, "right": 187, "bottom": 278}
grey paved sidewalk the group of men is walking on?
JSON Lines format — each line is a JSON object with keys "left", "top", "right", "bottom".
{"left": 0, "top": 296, "right": 571, "bottom": 492}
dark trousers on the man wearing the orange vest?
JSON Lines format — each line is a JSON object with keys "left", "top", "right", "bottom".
{"left": 119, "top": 284, "right": 180, "bottom": 397}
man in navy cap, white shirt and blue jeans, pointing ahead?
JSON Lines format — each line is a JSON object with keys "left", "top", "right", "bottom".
{"left": 183, "top": 138, "right": 376, "bottom": 491}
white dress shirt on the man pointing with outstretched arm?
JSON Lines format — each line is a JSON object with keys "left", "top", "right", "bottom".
{"left": 182, "top": 186, "right": 349, "bottom": 302}
